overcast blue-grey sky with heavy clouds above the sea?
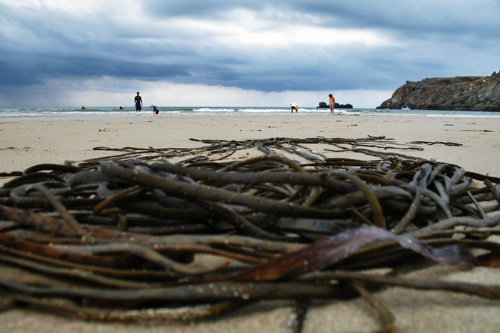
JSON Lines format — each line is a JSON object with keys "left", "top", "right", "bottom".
{"left": 0, "top": 0, "right": 500, "bottom": 107}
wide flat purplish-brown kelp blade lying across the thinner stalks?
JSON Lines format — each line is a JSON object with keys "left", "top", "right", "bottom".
{"left": 227, "top": 227, "right": 476, "bottom": 281}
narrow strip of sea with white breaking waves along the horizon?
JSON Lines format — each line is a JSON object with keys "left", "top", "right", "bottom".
{"left": 0, "top": 106, "right": 500, "bottom": 118}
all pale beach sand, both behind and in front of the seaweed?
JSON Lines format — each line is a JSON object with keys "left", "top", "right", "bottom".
{"left": 0, "top": 112, "right": 500, "bottom": 333}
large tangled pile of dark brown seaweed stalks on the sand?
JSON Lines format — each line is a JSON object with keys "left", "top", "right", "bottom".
{"left": 0, "top": 137, "right": 500, "bottom": 331}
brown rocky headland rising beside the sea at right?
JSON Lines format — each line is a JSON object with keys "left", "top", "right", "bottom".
{"left": 377, "top": 72, "right": 500, "bottom": 111}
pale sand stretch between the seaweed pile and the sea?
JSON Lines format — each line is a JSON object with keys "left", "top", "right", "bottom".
{"left": 0, "top": 112, "right": 500, "bottom": 176}
